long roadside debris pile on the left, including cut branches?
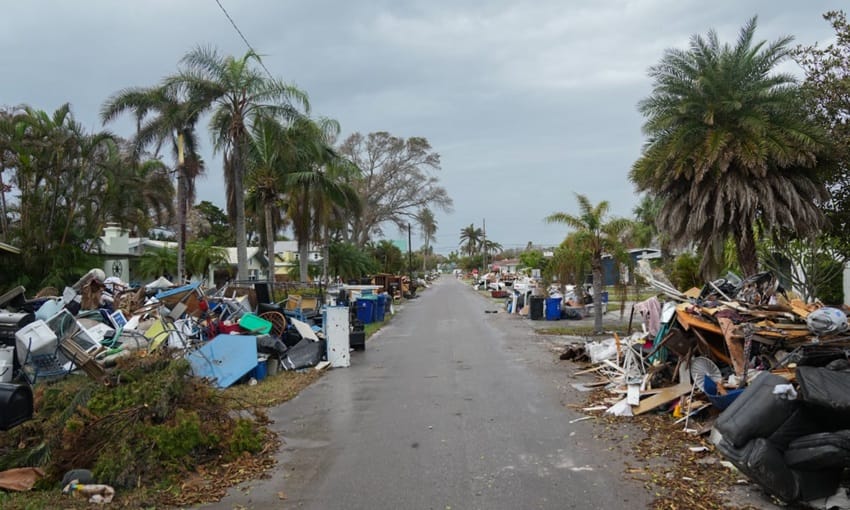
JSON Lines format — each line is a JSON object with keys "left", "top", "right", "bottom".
{"left": 0, "top": 269, "right": 384, "bottom": 502}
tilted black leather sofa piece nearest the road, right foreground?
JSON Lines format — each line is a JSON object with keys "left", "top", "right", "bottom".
{"left": 714, "top": 373, "right": 800, "bottom": 448}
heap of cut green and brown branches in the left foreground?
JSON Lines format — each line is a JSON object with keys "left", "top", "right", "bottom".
{"left": 0, "top": 354, "right": 265, "bottom": 488}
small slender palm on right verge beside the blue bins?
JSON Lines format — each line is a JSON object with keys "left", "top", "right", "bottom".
{"left": 546, "top": 193, "right": 632, "bottom": 333}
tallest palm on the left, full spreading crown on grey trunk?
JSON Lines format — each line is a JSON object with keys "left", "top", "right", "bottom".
{"left": 166, "top": 47, "right": 309, "bottom": 280}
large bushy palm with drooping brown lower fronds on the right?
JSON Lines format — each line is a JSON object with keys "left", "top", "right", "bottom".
{"left": 630, "top": 18, "right": 826, "bottom": 276}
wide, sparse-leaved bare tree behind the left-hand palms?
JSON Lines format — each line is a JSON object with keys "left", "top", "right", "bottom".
{"left": 339, "top": 131, "right": 452, "bottom": 247}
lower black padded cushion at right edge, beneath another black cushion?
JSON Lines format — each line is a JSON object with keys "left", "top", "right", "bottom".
{"left": 785, "top": 430, "right": 850, "bottom": 471}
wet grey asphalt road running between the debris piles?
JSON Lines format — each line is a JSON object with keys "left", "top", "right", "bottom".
{"left": 204, "top": 277, "right": 650, "bottom": 510}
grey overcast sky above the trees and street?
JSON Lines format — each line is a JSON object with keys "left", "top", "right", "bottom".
{"left": 0, "top": 0, "right": 847, "bottom": 253}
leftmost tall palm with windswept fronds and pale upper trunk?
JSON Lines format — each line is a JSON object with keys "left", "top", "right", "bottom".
{"left": 100, "top": 85, "right": 204, "bottom": 282}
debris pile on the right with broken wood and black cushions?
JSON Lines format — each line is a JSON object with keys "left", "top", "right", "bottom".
{"left": 561, "top": 262, "right": 850, "bottom": 502}
